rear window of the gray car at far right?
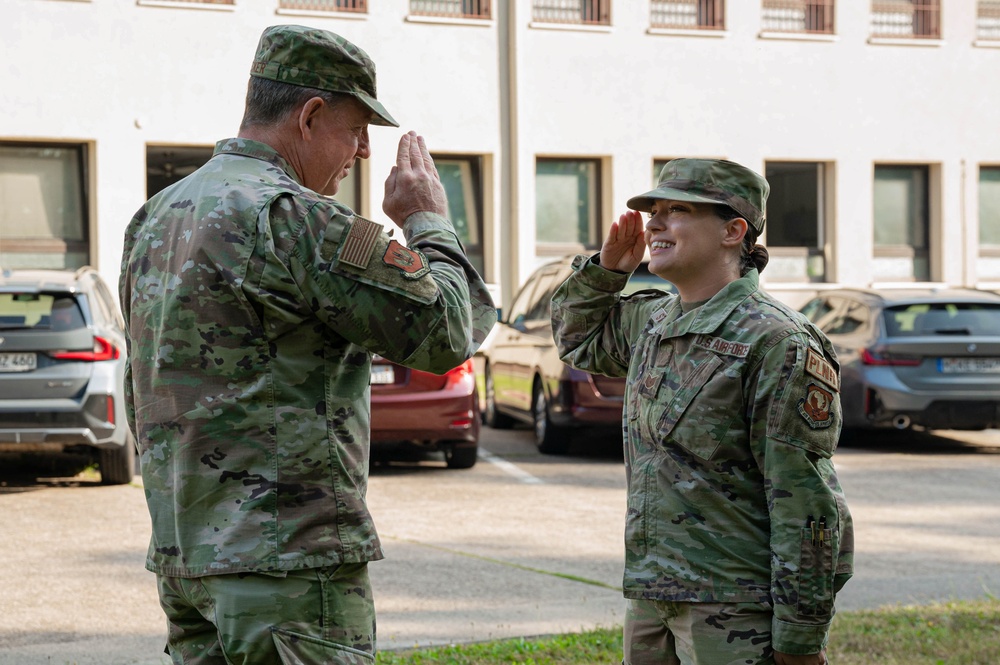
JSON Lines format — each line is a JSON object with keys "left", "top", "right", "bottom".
{"left": 882, "top": 303, "right": 1000, "bottom": 337}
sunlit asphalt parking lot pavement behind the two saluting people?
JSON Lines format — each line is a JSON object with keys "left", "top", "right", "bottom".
{"left": 0, "top": 428, "right": 1000, "bottom": 665}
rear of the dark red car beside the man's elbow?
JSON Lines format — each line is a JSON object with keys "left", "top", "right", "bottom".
{"left": 371, "top": 356, "right": 481, "bottom": 469}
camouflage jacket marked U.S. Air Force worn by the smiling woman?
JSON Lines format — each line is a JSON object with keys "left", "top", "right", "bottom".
{"left": 552, "top": 256, "right": 853, "bottom": 654}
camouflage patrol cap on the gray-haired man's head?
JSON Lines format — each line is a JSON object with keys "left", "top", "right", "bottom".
{"left": 250, "top": 25, "right": 399, "bottom": 127}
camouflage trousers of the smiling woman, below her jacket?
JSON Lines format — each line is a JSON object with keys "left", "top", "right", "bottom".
{"left": 622, "top": 600, "right": 774, "bottom": 665}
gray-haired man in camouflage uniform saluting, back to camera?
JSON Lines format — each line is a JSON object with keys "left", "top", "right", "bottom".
{"left": 120, "top": 26, "right": 496, "bottom": 665}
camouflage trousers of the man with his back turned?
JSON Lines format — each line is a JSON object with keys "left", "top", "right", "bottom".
{"left": 157, "top": 563, "right": 375, "bottom": 665}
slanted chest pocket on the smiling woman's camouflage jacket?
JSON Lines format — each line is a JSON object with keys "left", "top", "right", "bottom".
{"left": 659, "top": 355, "right": 743, "bottom": 460}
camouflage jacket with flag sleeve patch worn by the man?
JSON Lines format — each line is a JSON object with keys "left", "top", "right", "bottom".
{"left": 120, "top": 139, "right": 496, "bottom": 577}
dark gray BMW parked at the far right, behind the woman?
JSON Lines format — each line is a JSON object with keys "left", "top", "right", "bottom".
{"left": 802, "top": 288, "right": 1000, "bottom": 430}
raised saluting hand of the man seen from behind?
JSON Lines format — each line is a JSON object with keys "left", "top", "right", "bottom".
{"left": 382, "top": 132, "right": 448, "bottom": 227}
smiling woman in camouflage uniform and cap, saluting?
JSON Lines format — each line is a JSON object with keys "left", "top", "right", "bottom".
{"left": 552, "top": 159, "right": 853, "bottom": 665}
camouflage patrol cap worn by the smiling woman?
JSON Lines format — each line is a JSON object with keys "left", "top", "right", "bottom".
{"left": 627, "top": 159, "right": 771, "bottom": 233}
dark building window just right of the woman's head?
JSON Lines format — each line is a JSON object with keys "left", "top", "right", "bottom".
{"left": 764, "top": 162, "right": 827, "bottom": 282}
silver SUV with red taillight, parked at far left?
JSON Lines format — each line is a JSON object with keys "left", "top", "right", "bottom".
{"left": 0, "top": 268, "right": 136, "bottom": 485}
